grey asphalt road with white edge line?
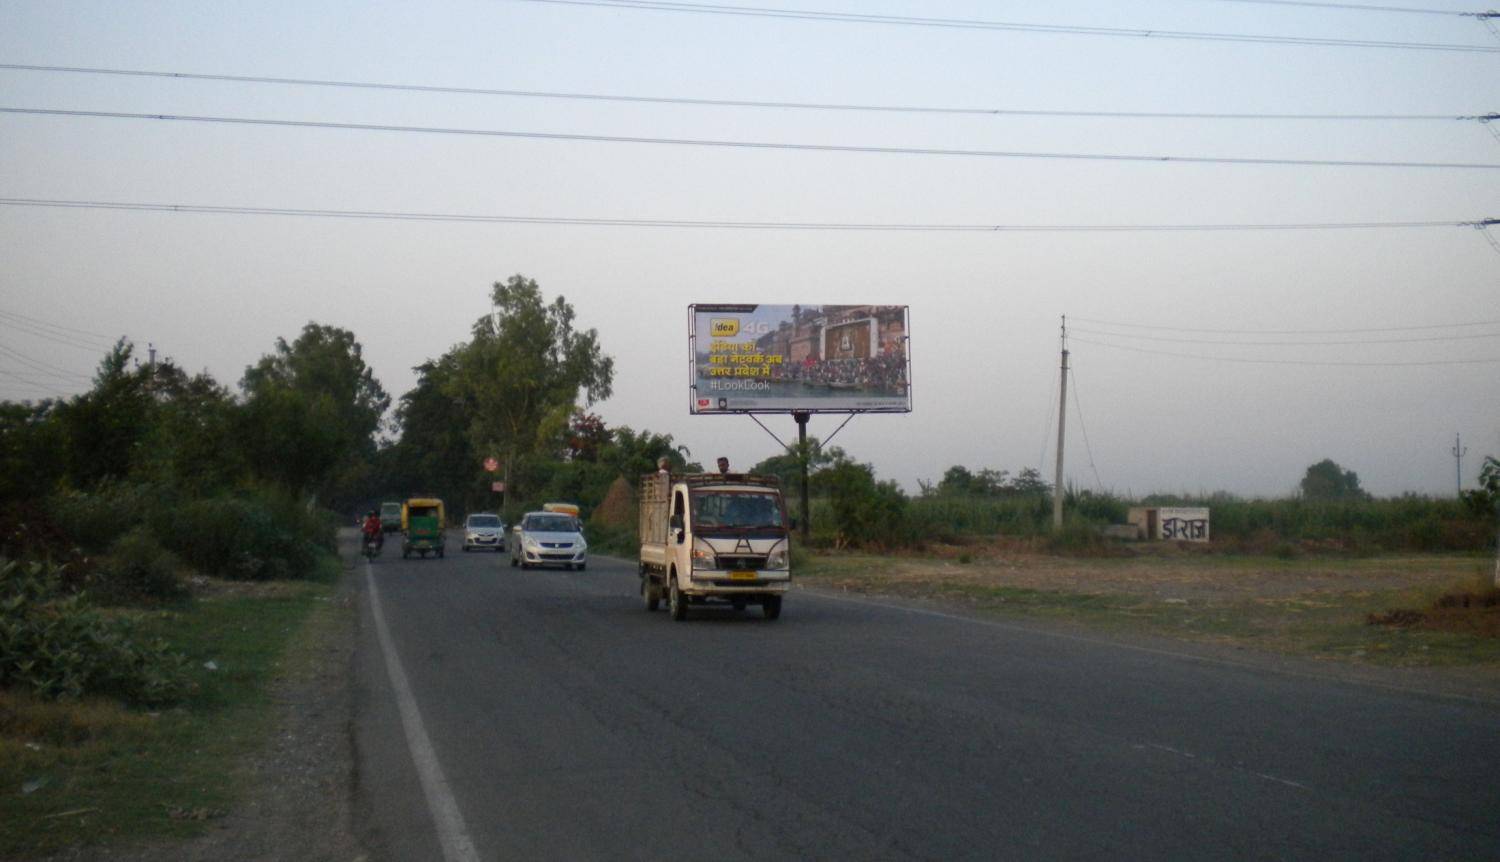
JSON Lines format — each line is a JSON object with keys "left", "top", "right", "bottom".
{"left": 354, "top": 540, "right": 1500, "bottom": 861}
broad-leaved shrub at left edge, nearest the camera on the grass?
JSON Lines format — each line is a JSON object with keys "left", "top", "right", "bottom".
{"left": 0, "top": 561, "right": 189, "bottom": 705}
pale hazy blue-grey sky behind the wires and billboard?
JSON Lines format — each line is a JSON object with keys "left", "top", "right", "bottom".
{"left": 0, "top": 0, "right": 1500, "bottom": 496}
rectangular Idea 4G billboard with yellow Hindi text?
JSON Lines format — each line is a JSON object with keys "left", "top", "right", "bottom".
{"left": 687, "top": 304, "right": 912, "bottom": 414}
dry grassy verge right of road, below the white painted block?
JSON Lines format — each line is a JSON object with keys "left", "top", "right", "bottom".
{"left": 798, "top": 553, "right": 1500, "bottom": 667}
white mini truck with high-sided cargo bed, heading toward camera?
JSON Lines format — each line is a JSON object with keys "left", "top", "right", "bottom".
{"left": 641, "top": 472, "right": 792, "bottom": 621}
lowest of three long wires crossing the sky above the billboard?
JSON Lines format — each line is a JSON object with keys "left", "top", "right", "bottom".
{"left": 0, "top": 198, "right": 1479, "bottom": 232}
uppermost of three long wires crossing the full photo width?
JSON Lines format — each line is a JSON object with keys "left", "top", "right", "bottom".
{"left": 0, "top": 63, "right": 1500, "bottom": 123}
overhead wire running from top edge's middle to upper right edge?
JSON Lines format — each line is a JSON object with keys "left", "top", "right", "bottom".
{"left": 524, "top": 0, "right": 1500, "bottom": 54}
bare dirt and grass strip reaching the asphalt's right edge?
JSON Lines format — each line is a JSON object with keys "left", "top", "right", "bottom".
{"left": 798, "top": 546, "right": 1500, "bottom": 705}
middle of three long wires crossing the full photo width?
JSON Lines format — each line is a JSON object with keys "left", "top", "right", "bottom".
{"left": 0, "top": 106, "right": 1500, "bottom": 171}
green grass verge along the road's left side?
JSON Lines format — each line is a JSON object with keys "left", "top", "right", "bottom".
{"left": 0, "top": 558, "right": 338, "bottom": 859}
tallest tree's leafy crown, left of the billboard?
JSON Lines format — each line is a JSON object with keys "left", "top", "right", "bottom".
{"left": 447, "top": 274, "right": 615, "bottom": 503}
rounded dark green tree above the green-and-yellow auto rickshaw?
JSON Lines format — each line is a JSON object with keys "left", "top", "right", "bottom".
{"left": 240, "top": 324, "right": 390, "bottom": 493}
